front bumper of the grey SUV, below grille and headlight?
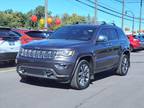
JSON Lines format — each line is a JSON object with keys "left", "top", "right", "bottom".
{"left": 17, "top": 60, "right": 74, "bottom": 82}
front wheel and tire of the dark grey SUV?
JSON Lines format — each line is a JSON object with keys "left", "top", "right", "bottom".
{"left": 71, "top": 60, "right": 91, "bottom": 90}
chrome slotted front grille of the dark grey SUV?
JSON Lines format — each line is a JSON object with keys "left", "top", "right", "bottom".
{"left": 20, "top": 49, "right": 55, "bottom": 59}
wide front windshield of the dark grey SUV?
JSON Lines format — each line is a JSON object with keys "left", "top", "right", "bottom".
{"left": 49, "top": 26, "right": 96, "bottom": 41}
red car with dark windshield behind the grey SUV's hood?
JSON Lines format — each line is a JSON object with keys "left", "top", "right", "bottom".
{"left": 21, "top": 31, "right": 52, "bottom": 44}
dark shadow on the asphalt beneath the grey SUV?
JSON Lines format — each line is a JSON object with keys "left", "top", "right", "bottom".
{"left": 20, "top": 71, "right": 116, "bottom": 89}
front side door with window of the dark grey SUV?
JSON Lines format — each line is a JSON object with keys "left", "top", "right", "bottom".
{"left": 95, "top": 28, "right": 112, "bottom": 72}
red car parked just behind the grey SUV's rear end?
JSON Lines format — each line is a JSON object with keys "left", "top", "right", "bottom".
{"left": 127, "top": 35, "right": 141, "bottom": 51}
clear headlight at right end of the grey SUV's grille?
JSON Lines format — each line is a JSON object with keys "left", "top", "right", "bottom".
{"left": 55, "top": 50, "right": 75, "bottom": 57}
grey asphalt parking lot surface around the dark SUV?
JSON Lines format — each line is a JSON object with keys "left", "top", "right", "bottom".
{"left": 0, "top": 51, "right": 144, "bottom": 108}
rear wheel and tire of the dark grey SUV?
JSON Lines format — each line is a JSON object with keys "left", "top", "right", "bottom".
{"left": 116, "top": 54, "right": 130, "bottom": 76}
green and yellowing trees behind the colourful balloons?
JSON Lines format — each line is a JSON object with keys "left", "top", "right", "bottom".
{"left": 0, "top": 6, "right": 91, "bottom": 30}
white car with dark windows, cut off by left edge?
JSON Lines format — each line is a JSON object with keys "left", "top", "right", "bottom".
{"left": 0, "top": 27, "right": 21, "bottom": 62}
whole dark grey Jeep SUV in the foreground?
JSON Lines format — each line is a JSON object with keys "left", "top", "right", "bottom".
{"left": 17, "top": 24, "right": 130, "bottom": 89}
